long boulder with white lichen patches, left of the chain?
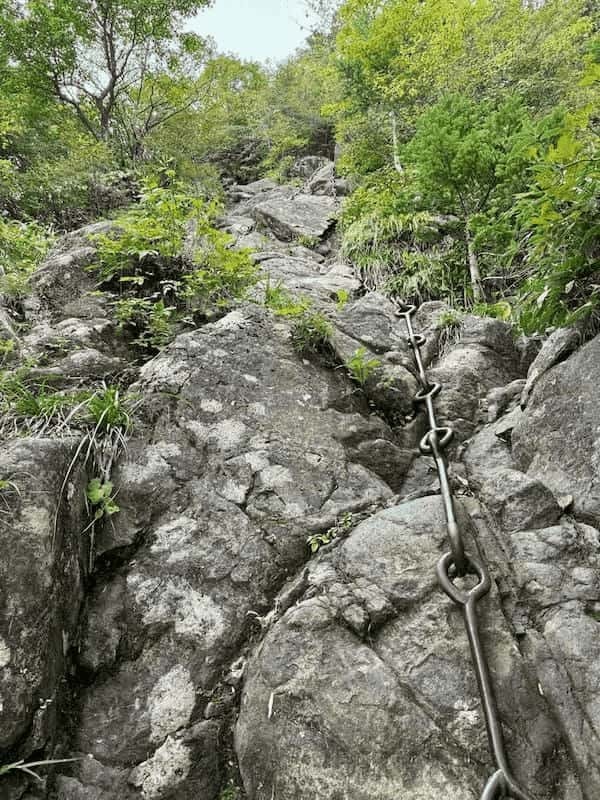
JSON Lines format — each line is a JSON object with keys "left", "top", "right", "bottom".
{"left": 57, "top": 307, "right": 403, "bottom": 800}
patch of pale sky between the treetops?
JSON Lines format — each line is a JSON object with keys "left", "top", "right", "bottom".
{"left": 192, "top": 0, "right": 316, "bottom": 62}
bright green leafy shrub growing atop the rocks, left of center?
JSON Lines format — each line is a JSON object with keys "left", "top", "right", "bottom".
{"left": 93, "top": 182, "right": 258, "bottom": 349}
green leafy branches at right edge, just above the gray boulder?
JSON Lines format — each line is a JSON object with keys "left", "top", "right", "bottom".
{"left": 511, "top": 112, "right": 600, "bottom": 333}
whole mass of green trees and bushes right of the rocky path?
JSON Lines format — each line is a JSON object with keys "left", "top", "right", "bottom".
{"left": 331, "top": 0, "right": 600, "bottom": 331}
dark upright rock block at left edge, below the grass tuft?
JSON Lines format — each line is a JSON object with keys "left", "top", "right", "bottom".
{"left": 0, "top": 439, "right": 87, "bottom": 760}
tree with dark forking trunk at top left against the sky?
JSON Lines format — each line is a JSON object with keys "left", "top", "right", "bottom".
{"left": 8, "top": 0, "right": 210, "bottom": 156}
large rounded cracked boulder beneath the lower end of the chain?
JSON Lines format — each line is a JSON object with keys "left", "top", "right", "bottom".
{"left": 236, "top": 498, "right": 573, "bottom": 800}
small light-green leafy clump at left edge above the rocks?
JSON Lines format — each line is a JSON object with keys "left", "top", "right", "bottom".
{"left": 0, "top": 217, "right": 53, "bottom": 300}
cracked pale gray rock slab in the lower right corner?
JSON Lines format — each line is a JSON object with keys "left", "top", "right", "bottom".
{"left": 510, "top": 521, "right": 600, "bottom": 799}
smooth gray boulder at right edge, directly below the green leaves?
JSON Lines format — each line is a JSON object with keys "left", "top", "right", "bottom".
{"left": 512, "top": 336, "right": 600, "bottom": 523}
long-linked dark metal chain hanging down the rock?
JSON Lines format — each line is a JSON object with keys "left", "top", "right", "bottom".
{"left": 393, "top": 299, "right": 533, "bottom": 800}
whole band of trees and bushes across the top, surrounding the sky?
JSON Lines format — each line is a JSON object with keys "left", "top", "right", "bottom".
{"left": 0, "top": 0, "right": 600, "bottom": 330}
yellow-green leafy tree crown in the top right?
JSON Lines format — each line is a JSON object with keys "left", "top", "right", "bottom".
{"left": 335, "top": 0, "right": 597, "bottom": 175}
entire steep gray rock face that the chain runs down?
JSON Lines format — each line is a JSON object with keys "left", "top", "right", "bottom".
{"left": 0, "top": 160, "right": 600, "bottom": 800}
